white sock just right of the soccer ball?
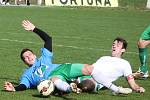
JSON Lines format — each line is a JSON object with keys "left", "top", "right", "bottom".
{"left": 54, "top": 79, "right": 71, "bottom": 92}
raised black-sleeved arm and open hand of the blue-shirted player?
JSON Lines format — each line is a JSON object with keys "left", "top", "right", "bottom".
{"left": 22, "top": 20, "right": 52, "bottom": 52}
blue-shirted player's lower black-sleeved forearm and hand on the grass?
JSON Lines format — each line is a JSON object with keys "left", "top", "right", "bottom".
{"left": 4, "top": 82, "right": 27, "bottom": 92}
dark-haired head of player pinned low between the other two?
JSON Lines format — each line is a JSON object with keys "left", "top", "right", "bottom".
{"left": 78, "top": 79, "right": 95, "bottom": 92}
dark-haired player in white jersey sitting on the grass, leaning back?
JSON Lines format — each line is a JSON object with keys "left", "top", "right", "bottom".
{"left": 83, "top": 37, "right": 145, "bottom": 94}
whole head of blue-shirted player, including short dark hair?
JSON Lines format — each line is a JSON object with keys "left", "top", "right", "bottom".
{"left": 20, "top": 48, "right": 36, "bottom": 66}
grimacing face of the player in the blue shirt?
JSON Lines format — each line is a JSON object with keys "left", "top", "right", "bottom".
{"left": 23, "top": 51, "right": 36, "bottom": 66}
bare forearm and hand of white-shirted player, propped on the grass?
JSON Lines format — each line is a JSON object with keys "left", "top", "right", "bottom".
{"left": 127, "top": 74, "right": 145, "bottom": 93}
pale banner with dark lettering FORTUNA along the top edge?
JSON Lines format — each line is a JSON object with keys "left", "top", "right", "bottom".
{"left": 45, "top": 0, "right": 118, "bottom": 7}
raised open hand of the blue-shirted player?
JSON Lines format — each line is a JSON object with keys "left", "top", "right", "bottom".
{"left": 22, "top": 20, "right": 35, "bottom": 31}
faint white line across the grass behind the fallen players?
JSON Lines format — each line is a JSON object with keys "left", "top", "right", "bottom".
{"left": 0, "top": 39, "right": 138, "bottom": 54}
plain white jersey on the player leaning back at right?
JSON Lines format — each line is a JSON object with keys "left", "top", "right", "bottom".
{"left": 92, "top": 56, "right": 132, "bottom": 87}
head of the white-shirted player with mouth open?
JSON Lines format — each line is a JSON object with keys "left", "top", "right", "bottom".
{"left": 112, "top": 37, "right": 128, "bottom": 57}
